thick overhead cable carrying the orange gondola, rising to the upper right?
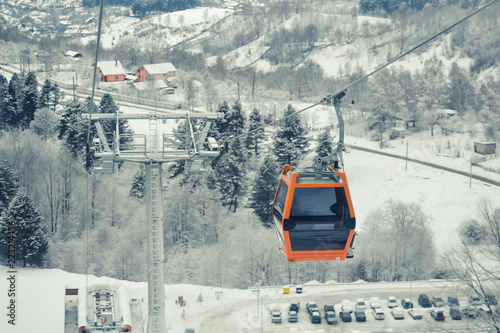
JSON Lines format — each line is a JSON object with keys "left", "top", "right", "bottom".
{"left": 228, "top": 0, "right": 498, "bottom": 144}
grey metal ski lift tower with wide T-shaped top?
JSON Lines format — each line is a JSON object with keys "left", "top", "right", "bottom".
{"left": 83, "top": 111, "right": 223, "bottom": 333}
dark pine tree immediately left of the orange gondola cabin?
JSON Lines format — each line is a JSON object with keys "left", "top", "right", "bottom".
{"left": 249, "top": 155, "right": 280, "bottom": 227}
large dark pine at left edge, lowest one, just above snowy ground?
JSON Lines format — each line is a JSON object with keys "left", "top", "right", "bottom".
{"left": 0, "top": 191, "right": 49, "bottom": 267}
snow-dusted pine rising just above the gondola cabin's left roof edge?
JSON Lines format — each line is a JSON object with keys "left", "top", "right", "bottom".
{"left": 272, "top": 105, "right": 309, "bottom": 164}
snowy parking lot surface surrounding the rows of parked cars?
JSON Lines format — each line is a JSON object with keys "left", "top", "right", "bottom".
{"left": 216, "top": 283, "right": 500, "bottom": 333}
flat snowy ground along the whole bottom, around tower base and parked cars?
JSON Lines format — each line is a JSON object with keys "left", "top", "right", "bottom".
{"left": 0, "top": 267, "right": 496, "bottom": 333}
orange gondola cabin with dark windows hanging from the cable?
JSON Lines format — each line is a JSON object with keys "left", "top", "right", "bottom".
{"left": 272, "top": 165, "right": 356, "bottom": 261}
